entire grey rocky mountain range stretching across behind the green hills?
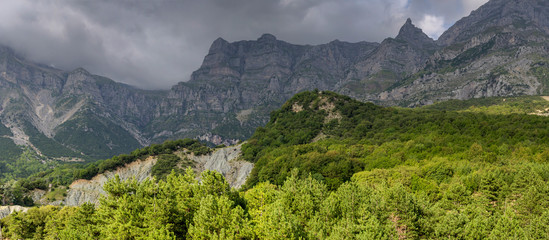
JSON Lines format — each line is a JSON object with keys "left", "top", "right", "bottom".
{"left": 0, "top": 0, "right": 549, "bottom": 161}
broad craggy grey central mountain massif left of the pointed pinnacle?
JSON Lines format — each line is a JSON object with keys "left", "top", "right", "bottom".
{"left": 158, "top": 34, "right": 378, "bottom": 143}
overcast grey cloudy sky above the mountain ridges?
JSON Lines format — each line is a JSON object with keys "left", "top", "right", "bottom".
{"left": 0, "top": 0, "right": 488, "bottom": 89}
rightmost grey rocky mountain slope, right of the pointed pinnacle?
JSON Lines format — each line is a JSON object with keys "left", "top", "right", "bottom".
{"left": 382, "top": 0, "right": 549, "bottom": 106}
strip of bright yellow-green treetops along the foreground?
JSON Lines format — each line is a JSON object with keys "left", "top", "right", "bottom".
{"left": 6, "top": 159, "right": 549, "bottom": 239}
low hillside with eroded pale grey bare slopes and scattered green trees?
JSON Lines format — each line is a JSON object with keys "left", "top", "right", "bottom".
{"left": 0, "top": 139, "right": 253, "bottom": 206}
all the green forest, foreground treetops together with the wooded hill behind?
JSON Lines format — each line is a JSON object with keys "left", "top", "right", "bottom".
{"left": 0, "top": 91, "right": 549, "bottom": 239}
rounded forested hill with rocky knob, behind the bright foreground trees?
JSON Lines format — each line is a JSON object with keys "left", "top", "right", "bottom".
{"left": 242, "top": 92, "right": 549, "bottom": 190}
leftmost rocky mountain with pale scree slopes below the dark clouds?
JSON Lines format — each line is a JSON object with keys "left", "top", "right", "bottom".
{"left": 0, "top": 48, "right": 147, "bottom": 159}
